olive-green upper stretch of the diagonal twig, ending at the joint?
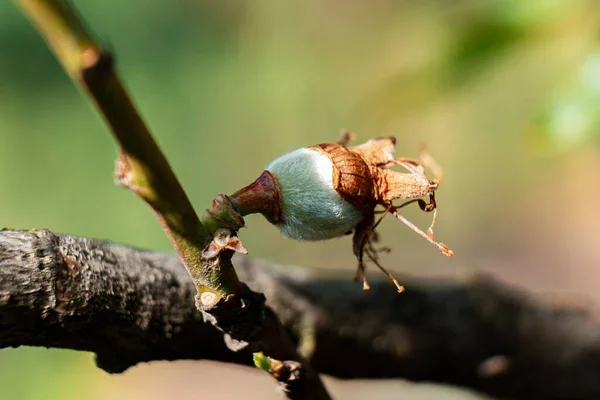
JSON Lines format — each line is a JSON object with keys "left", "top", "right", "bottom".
{"left": 17, "top": 0, "right": 239, "bottom": 301}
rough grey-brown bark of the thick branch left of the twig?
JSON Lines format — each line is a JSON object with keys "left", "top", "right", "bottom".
{"left": 0, "top": 231, "right": 246, "bottom": 372}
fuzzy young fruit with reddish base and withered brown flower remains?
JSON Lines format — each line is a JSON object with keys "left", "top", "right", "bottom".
{"left": 230, "top": 132, "right": 453, "bottom": 292}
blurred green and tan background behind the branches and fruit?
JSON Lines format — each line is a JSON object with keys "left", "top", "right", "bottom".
{"left": 0, "top": 0, "right": 600, "bottom": 400}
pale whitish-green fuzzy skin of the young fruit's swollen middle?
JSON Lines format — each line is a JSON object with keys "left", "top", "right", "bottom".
{"left": 266, "top": 148, "right": 363, "bottom": 240}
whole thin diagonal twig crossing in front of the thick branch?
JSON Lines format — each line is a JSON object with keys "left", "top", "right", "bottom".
{"left": 16, "top": 0, "right": 329, "bottom": 399}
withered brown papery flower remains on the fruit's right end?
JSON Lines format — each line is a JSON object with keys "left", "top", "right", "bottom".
{"left": 311, "top": 132, "right": 453, "bottom": 292}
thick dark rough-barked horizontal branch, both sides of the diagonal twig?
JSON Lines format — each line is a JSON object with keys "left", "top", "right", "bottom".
{"left": 0, "top": 231, "right": 600, "bottom": 399}
